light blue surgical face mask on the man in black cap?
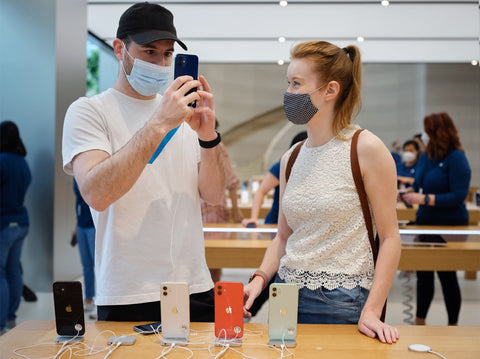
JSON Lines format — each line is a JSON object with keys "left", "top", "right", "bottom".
{"left": 122, "top": 47, "right": 172, "bottom": 96}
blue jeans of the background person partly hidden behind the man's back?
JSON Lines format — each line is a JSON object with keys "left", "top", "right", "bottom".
{"left": 77, "top": 227, "right": 95, "bottom": 298}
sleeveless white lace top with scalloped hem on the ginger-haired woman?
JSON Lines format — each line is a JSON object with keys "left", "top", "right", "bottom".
{"left": 278, "top": 129, "right": 375, "bottom": 290}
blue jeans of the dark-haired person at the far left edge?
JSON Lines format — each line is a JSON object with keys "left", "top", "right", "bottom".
{"left": 0, "top": 224, "right": 28, "bottom": 330}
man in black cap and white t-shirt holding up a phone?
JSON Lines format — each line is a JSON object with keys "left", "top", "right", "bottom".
{"left": 63, "top": 2, "right": 225, "bottom": 321}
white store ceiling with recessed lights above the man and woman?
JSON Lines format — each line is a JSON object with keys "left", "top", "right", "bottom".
{"left": 87, "top": 0, "right": 480, "bottom": 63}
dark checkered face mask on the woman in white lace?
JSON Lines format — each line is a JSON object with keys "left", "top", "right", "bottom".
{"left": 283, "top": 82, "right": 328, "bottom": 125}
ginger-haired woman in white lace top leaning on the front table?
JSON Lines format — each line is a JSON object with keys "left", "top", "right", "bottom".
{"left": 245, "top": 41, "right": 400, "bottom": 343}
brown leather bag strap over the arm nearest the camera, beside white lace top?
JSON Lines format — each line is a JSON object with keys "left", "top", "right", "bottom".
{"left": 350, "top": 129, "right": 378, "bottom": 263}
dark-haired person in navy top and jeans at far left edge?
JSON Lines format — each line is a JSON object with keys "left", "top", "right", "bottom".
{"left": 0, "top": 121, "right": 31, "bottom": 334}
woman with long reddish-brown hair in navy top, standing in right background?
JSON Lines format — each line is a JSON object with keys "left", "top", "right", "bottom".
{"left": 402, "top": 113, "right": 471, "bottom": 325}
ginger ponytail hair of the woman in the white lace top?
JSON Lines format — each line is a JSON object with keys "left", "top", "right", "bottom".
{"left": 291, "top": 41, "right": 362, "bottom": 135}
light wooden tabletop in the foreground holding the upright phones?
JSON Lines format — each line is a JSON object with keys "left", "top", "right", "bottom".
{"left": 0, "top": 320, "right": 480, "bottom": 359}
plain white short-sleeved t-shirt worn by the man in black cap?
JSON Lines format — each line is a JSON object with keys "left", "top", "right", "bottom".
{"left": 62, "top": 89, "right": 213, "bottom": 305}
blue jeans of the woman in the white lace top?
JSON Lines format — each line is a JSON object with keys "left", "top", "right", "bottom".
{"left": 275, "top": 276, "right": 369, "bottom": 324}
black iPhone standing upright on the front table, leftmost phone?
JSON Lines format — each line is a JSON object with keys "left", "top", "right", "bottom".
{"left": 53, "top": 281, "right": 85, "bottom": 341}
